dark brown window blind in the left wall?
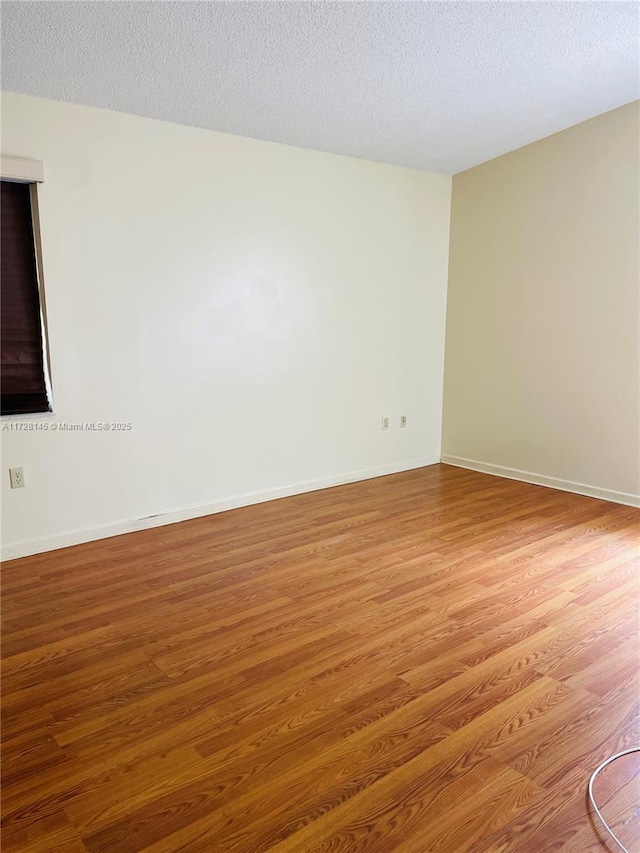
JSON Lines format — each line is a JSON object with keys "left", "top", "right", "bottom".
{"left": 0, "top": 181, "right": 50, "bottom": 415}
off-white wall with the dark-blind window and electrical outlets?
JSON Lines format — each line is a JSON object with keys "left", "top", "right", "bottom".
{"left": 2, "top": 94, "right": 451, "bottom": 555}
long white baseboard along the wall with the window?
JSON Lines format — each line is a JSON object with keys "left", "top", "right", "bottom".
{"left": 1, "top": 456, "right": 440, "bottom": 560}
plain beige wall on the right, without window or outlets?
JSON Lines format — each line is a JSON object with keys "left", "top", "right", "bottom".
{"left": 443, "top": 103, "right": 640, "bottom": 502}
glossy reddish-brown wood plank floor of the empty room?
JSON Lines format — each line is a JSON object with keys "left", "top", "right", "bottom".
{"left": 2, "top": 465, "right": 640, "bottom": 853}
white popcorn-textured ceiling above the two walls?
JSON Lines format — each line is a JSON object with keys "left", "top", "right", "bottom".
{"left": 2, "top": 0, "right": 640, "bottom": 173}
